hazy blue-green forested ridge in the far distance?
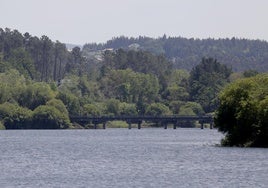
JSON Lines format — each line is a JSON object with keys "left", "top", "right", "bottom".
{"left": 83, "top": 35, "right": 268, "bottom": 72}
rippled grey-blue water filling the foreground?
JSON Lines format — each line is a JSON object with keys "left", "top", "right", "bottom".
{"left": 0, "top": 128, "right": 268, "bottom": 188}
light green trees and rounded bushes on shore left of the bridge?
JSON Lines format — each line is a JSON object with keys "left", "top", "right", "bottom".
{"left": 0, "top": 69, "right": 71, "bottom": 129}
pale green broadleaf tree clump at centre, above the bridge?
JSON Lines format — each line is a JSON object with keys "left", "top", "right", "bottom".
{"left": 101, "top": 69, "right": 160, "bottom": 103}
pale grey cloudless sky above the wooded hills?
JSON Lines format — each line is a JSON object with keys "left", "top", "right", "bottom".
{"left": 0, "top": 0, "right": 268, "bottom": 45}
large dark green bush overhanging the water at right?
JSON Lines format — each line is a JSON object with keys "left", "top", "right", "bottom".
{"left": 215, "top": 74, "right": 268, "bottom": 147}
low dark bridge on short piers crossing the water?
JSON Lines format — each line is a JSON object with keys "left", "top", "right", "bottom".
{"left": 70, "top": 116, "right": 213, "bottom": 129}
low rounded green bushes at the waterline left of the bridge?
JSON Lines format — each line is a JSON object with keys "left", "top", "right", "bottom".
{"left": 0, "top": 99, "right": 70, "bottom": 129}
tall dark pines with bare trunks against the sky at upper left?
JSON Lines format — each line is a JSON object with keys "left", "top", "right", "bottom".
{"left": 0, "top": 28, "right": 82, "bottom": 82}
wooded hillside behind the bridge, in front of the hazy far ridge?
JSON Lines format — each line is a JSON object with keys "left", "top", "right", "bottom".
{"left": 0, "top": 28, "right": 264, "bottom": 129}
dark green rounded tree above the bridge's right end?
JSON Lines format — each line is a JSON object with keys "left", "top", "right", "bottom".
{"left": 189, "top": 58, "right": 231, "bottom": 113}
